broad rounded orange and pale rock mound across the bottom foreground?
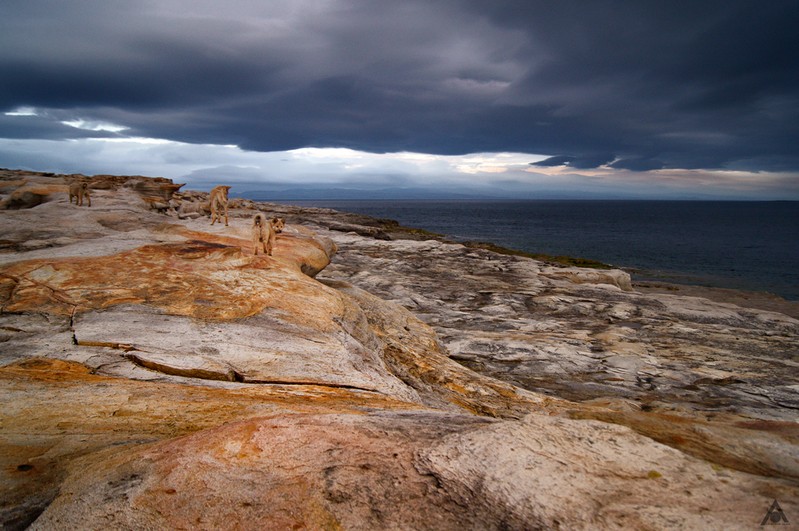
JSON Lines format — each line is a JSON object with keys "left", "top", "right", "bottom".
{"left": 31, "top": 412, "right": 799, "bottom": 530}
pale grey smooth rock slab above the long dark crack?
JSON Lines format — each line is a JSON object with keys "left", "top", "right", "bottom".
{"left": 74, "top": 306, "right": 418, "bottom": 401}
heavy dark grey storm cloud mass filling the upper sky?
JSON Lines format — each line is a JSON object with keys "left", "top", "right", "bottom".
{"left": 0, "top": 0, "right": 799, "bottom": 171}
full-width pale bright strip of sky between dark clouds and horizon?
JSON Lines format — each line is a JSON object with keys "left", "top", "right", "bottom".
{"left": 0, "top": 121, "right": 799, "bottom": 199}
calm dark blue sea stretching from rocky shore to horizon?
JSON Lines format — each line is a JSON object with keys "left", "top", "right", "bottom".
{"left": 293, "top": 200, "right": 799, "bottom": 300}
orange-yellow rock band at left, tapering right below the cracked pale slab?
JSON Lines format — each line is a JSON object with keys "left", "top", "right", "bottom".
{"left": 0, "top": 358, "right": 418, "bottom": 529}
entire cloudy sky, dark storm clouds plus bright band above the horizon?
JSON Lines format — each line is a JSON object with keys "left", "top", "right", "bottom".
{"left": 0, "top": 0, "right": 799, "bottom": 200}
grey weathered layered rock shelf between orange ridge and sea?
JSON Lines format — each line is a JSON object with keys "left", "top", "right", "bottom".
{"left": 319, "top": 229, "right": 799, "bottom": 420}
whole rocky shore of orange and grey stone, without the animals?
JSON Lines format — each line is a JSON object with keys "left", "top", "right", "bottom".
{"left": 0, "top": 170, "right": 799, "bottom": 529}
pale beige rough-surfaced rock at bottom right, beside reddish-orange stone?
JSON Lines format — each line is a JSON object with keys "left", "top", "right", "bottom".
{"left": 419, "top": 415, "right": 796, "bottom": 529}
